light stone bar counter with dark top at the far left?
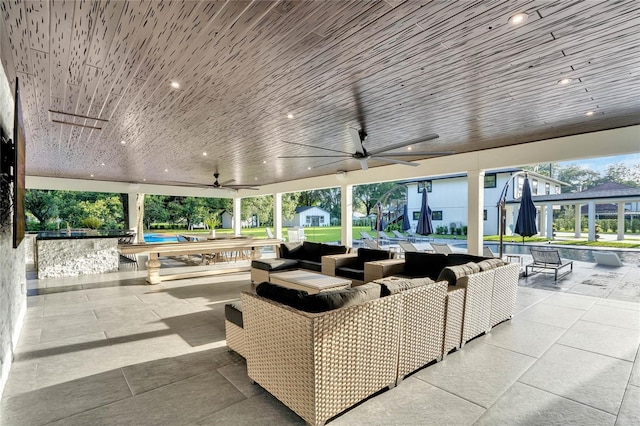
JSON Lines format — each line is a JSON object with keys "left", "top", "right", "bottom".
{"left": 34, "top": 231, "right": 125, "bottom": 278}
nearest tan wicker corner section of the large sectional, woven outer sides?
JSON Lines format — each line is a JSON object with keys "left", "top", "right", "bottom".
{"left": 241, "top": 293, "right": 402, "bottom": 425}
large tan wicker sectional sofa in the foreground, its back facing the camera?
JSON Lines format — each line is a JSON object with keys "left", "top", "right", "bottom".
{"left": 226, "top": 260, "right": 519, "bottom": 424}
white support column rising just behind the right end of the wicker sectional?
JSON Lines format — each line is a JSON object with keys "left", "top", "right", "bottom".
{"left": 467, "top": 170, "right": 484, "bottom": 256}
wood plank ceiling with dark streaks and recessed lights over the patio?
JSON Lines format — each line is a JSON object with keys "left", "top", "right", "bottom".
{"left": 0, "top": 0, "right": 640, "bottom": 188}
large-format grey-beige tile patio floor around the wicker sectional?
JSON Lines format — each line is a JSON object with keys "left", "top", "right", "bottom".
{"left": 0, "top": 255, "right": 640, "bottom": 426}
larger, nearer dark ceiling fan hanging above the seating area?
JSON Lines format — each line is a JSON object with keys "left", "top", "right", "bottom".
{"left": 278, "top": 85, "right": 454, "bottom": 170}
